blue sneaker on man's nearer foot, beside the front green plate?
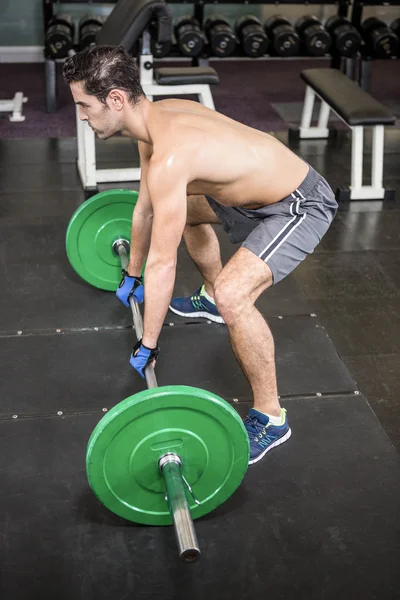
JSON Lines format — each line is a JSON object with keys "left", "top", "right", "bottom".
{"left": 244, "top": 408, "right": 292, "bottom": 465}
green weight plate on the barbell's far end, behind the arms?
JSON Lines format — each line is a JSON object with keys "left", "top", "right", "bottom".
{"left": 66, "top": 190, "right": 138, "bottom": 291}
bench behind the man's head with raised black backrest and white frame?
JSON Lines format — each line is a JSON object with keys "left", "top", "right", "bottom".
{"left": 76, "top": 0, "right": 219, "bottom": 197}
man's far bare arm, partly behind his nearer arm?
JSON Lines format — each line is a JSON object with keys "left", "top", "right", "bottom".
{"left": 128, "top": 142, "right": 153, "bottom": 277}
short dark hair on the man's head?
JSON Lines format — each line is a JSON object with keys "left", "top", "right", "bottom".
{"left": 63, "top": 46, "right": 144, "bottom": 104}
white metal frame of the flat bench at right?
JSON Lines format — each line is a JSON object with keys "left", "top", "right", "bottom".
{"left": 300, "top": 85, "right": 385, "bottom": 200}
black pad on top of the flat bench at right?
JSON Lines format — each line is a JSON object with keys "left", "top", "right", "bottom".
{"left": 300, "top": 69, "right": 396, "bottom": 126}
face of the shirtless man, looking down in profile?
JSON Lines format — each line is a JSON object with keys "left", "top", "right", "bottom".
{"left": 70, "top": 82, "right": 123, "bottom": 140}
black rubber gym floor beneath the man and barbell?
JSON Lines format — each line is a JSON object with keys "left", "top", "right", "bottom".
{"left": 0, "top": 131, "right": 400, "bottom": 600}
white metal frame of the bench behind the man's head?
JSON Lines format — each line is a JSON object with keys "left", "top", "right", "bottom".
{"left": 76, "top": 31, "right": 215, "bottom": 191}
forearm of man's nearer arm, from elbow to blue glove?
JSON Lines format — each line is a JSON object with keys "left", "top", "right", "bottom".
{"left": 142, "top": 261, "right": 176, "bottom": 348}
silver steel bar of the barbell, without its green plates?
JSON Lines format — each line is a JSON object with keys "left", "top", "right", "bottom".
{"left": 115, "top": 241, "right": 200, "bottom": 562}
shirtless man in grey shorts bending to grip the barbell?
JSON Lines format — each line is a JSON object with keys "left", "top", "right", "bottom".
{"left": 64, "top": 46, "right": 337, "bottom": 464}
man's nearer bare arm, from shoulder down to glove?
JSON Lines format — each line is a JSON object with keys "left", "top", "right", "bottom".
{"left": 142, "top": 160, "right": 187, "bottom": 348}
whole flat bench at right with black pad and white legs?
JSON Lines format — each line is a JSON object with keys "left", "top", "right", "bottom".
{"left": 299, "top": 69, "right": 396, "bottom": 200}
